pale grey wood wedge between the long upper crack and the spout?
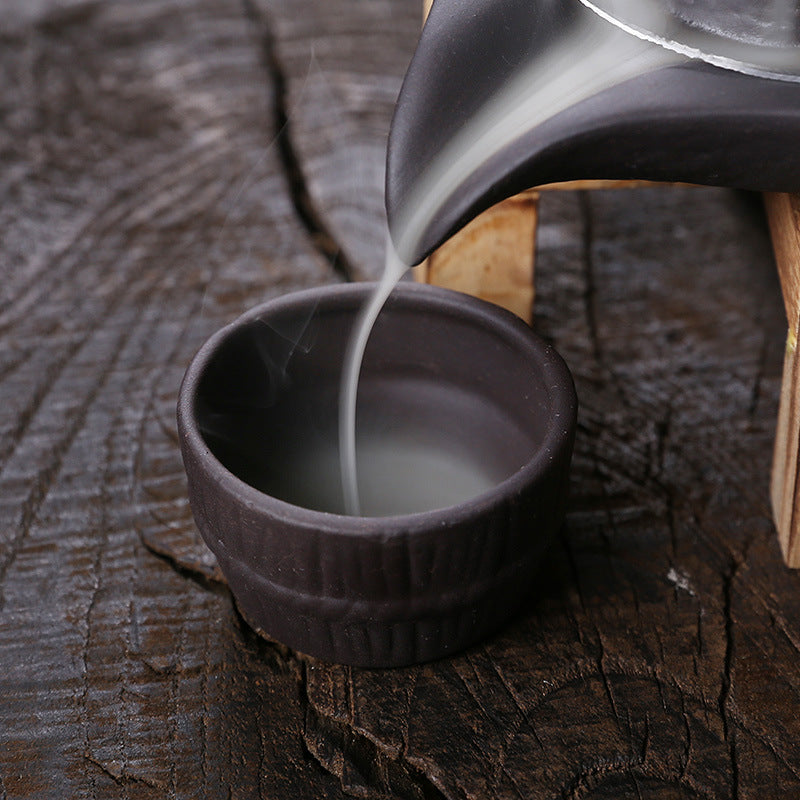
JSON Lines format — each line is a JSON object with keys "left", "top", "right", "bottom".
{"left": 252, "top": 0, "right": 420, "bottom": 279}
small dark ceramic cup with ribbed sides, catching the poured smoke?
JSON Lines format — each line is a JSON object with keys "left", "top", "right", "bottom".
{"left": 178, "top": 283, "right": 577, "bottom": 667}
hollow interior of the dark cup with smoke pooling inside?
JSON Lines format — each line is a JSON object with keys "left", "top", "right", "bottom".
{"left": 195, "top": 287, "right": 559, "bottom": 517}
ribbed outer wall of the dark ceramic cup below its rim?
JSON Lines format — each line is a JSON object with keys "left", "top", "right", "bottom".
{"left": 179, "top": 416, "right": 571, "bottom": 667}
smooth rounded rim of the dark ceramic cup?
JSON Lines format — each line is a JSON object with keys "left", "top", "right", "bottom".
{"left": 177, "top": 281, "right": 578, "bottom": 537}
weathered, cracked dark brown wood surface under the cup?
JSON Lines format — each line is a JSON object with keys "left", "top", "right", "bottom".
{"left": 0, "top": 0, "right": 800, "bottom": 800}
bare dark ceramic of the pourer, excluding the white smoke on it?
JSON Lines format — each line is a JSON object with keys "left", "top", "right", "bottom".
{"left": 386, "top": 0, "right": 800, "bottom": 263}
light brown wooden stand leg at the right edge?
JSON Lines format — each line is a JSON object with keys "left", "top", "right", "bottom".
{"left": 764, "top": 194, "right": 800, "bottom": 568}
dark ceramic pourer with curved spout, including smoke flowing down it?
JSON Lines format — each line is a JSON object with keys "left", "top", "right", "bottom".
{"left": 386, "top": 0, "right": 800, "bottom": 263}
